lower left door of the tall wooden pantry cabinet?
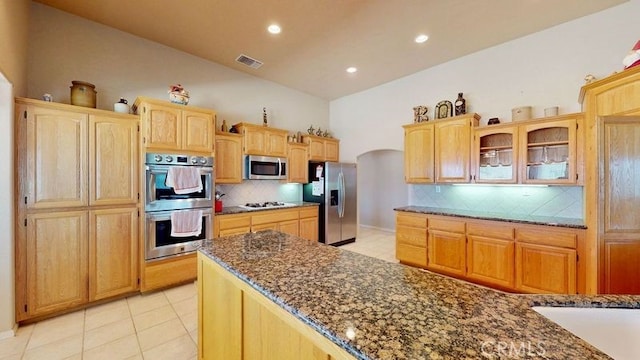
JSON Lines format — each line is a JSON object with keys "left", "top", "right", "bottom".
{"left": 26, "top": 211, "right": 88, "bottom": 316}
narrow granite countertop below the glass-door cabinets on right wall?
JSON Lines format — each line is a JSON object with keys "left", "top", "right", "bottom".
{"left": 393, "top": 206, "right": 587, "bottom": 229}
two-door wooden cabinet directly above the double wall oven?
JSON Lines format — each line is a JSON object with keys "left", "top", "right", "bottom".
{"left": 133, "top": 97, "right": 215, "bottom": 152}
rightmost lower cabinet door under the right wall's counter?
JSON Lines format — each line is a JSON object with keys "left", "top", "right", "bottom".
{"left": 515, "top": 243, "right": 577, "bottom": 294}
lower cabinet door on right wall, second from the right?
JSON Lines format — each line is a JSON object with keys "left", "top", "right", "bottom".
{"left": 467, "top": 235, "right": 515, "bottom": 288}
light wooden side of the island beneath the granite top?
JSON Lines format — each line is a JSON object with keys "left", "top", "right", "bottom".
{"left": 198, "top": 254, "right": 353, "bottom": 360}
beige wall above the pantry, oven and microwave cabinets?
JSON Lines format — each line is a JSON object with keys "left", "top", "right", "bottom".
{"left": 28, "top": 3, "right": 329, "bottom": 132}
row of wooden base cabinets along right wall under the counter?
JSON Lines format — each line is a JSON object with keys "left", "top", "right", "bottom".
{"left": 396, "top": 211, "right": 584, "bottom": 294}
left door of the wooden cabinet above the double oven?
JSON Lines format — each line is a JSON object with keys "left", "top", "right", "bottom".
{"left": 142, "top": 104, "right": 182, "bottom": 150}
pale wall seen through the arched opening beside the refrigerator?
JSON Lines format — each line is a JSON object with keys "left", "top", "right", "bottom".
{"left": 358, "top": 150, "right": 408, "bottom": 231}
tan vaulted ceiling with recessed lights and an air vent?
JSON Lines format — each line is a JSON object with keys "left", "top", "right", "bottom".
{"left": 34, "top": 0, "right": 626, "bottom": 100}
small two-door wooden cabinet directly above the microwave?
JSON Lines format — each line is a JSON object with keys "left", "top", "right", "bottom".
{"left": 235, "top": 123, "right": 288, "bottom": 157}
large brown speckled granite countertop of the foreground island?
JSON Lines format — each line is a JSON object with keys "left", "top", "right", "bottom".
{"left": 200, "top": 230, "right": 640, "bottom": 360}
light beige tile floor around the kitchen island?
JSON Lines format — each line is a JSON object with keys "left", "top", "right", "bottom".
{"left": 0, "top": 227, "right": 397, "bottom": 360}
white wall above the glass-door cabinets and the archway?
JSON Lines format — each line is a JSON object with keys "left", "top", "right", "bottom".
{"left": 330, "top": 0, "right": 640, "bottom": 161}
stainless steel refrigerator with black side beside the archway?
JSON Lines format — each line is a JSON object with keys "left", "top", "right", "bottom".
{"left": 303, "top": 162, "right": 358, "bottom": 246}
